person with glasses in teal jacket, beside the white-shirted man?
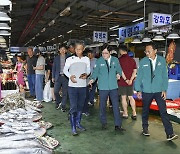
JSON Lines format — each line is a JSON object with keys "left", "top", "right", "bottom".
{"left": 89, "top": 44, "right": 125, "bottom": 132}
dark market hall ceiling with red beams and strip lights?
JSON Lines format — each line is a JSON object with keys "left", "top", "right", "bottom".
{"left": 7, "top": 0, "right": 180, "bottom": 46}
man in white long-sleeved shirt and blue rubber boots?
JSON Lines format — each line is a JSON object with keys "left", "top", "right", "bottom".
{"left": 63, "top": 43, "right": 90, "bottom": 135}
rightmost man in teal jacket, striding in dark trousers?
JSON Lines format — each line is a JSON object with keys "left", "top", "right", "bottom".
{"left": 135, "top": 43, "right": 178, "bottom": 141}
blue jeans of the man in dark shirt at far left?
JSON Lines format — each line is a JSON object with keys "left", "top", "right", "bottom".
{"left": 27, "top": 74, "right": 36, "bottom": 96}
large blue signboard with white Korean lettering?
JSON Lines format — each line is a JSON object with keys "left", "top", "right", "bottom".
{"left": 119, "top": 22, "right": 144, "bottom": 42}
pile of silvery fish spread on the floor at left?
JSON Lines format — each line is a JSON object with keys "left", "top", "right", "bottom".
{"left": 0, "top": 93, "right": 59, "bottom": 154}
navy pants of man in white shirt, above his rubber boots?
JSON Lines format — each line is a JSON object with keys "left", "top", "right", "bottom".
{"left": 68, "top": 87, "right": 86, "bottom": 114}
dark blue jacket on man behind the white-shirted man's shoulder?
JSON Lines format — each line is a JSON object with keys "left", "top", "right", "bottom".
{"left": 52, "top": 55, "right": 67, "bottom": 81}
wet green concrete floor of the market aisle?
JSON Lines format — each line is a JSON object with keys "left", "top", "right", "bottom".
{"left": 42, "top": 102, "right": 180, "bottom": 154}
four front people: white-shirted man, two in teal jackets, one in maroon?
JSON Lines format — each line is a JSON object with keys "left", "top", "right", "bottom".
{"left": 58, "top": 43, "right": 178, "bottom": 140}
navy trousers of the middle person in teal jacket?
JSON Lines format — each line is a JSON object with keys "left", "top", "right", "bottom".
{"left": 99, "top": 89, "right": 122, "bottom": 126}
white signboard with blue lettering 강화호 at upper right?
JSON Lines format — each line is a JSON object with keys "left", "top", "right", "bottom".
{"left": 148, "top": 13, "right": 172, "bottom": 32}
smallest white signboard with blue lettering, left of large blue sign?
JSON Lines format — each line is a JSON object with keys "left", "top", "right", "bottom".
{"left": 93, "top": 31, "right": 108, "bottom": 43}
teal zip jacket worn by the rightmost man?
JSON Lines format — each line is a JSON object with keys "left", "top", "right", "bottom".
{"left": 135, "top": 55, "right": 168, "bottom": 93}
